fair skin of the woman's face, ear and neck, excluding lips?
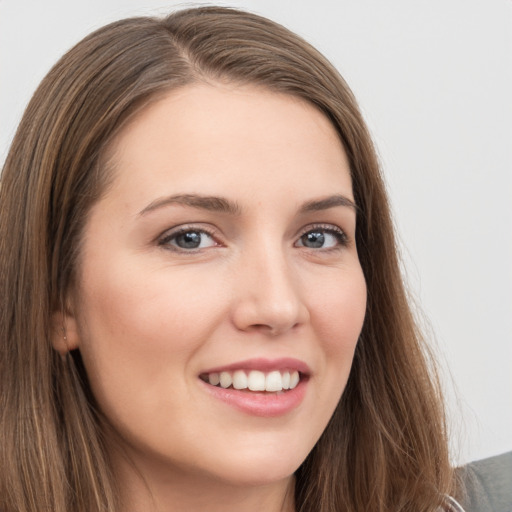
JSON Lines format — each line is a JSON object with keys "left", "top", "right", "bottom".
{"left": 54, "top": 84, "right": 366, "bottom": 512}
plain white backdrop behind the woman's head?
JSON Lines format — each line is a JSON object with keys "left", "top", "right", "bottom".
{"left": 0, "top": 0, "right": 512, "bottom": 463}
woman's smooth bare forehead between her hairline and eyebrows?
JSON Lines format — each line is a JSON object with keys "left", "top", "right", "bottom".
{"left": 102, "top": 84, "right": 352, "bottom": 211}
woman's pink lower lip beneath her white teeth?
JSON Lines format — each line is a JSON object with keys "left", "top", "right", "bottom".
{"left": 201, "top": 379, "right": 307, "bottom": 418}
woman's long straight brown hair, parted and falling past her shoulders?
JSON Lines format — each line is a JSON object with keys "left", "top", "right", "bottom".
{"left": 0, "top": 7, "right": 452, "bottom": 512}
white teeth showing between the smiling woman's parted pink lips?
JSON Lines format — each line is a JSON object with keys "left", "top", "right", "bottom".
{"left": 199, "top": 370, "right": 305, "bottom": 393}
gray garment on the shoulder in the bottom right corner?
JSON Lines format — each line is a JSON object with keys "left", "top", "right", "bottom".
{"left": 458, "top": 452, "right": 512, "bottom": 512}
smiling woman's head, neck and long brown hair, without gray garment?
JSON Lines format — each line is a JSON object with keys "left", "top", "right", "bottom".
{"left": 0, "top": 7, "right": 457, "bottom": 512}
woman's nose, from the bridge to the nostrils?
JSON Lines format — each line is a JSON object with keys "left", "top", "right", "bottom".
{"left": 232, "top": 241, "right": 309, "bottom": 336}
